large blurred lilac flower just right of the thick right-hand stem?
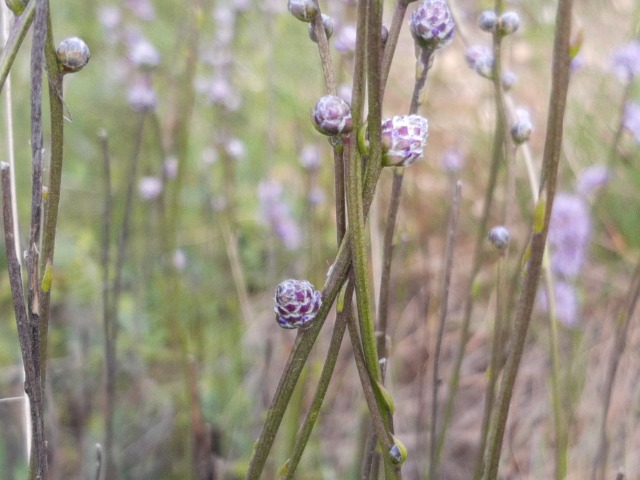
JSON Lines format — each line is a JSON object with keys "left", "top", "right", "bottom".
{"left": 547, "top": 193, "right": 591, "bottom": 278}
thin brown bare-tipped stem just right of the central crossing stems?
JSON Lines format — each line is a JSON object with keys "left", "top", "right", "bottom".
{"left": 429, "top": 180, "right": 462, "bottom": 479}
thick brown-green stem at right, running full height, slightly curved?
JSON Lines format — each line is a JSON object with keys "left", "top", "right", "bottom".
{"left": 483, "top": 0, "right": 572, "bottom": 480}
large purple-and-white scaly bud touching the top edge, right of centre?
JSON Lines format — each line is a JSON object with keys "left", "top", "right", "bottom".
{"left": 409, "top": 0, "right": 455, "bottom": 50}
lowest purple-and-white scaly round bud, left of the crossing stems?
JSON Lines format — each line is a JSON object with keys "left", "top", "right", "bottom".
{"left": 273, "top": 279, "right": 322, "bottom": 329}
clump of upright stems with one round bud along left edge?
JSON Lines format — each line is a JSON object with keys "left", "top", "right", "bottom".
{"left": 0, "top": 0, "right": 90, "bottom": 479}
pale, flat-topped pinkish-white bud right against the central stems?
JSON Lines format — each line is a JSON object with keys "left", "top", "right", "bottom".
{"left": 382, "top": 115, "right": 429, "bottom": 167}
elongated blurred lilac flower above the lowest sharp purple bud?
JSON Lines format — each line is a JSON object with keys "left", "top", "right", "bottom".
{"left": 258, "top": 180, "right": 302, "bottom": 250}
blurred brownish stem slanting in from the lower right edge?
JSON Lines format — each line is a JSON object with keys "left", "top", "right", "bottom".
{"left": 591, "top": 261, "right": 640, "bottom": 480}
